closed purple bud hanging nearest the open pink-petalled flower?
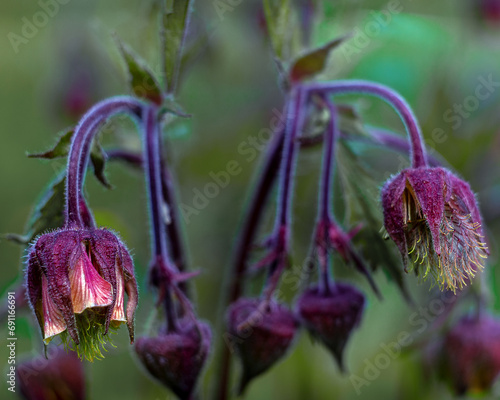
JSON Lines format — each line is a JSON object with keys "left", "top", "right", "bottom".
{"left": 135, "top": 317, "right": 211, "bottom": 400}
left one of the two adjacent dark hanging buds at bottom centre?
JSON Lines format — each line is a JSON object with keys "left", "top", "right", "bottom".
{"left": 227, "top": 298, "right": 298, "bottom": 394}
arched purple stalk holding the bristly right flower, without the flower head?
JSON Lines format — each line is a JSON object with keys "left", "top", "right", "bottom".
{"left": 303, "top": 80, "right": 427, "bottom": 168}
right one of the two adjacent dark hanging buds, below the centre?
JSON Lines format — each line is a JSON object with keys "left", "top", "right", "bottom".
{"left": 297, "top": 283, "right": 365, "bottom": 371}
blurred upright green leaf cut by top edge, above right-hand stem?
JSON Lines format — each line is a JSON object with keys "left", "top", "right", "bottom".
{"left": 264, "top": 0, "right": 291, "bottom": 60}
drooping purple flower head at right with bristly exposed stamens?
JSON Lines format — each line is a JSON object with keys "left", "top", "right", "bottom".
{"left": 382, "top": 168, "right": 488, "bottom": 291}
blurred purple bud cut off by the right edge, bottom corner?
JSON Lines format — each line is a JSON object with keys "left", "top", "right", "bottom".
{"left": 442, "top": 315, "right": 500, "bottom": 395}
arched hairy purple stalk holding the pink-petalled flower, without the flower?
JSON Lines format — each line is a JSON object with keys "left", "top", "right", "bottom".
{"left": 65, "top": 96, "right": 143, "bottom": 227}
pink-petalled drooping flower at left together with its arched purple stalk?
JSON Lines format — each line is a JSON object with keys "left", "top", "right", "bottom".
{"left": 26, "top": 97, "right": 142, "bottom": 360}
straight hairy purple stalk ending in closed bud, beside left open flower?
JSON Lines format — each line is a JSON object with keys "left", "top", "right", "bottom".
{"left": 135, "top": 106, "right": 211, "bottom": 400}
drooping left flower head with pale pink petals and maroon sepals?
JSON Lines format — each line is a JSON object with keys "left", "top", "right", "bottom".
{"left": 27, "top": 229, "right": 137, "bottom": 360}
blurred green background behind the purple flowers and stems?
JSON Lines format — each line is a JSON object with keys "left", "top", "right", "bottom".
{"left": 0, "top": 0, "right": 500, "bottom": 400}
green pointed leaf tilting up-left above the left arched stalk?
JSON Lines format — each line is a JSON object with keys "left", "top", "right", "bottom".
{"left": 115, "top": 37, "right": 163, "bottom": 104}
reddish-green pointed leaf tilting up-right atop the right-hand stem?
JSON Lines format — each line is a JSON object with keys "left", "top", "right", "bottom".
{"left": 289, "top": 36, "right": 349, "bottom": 82}
